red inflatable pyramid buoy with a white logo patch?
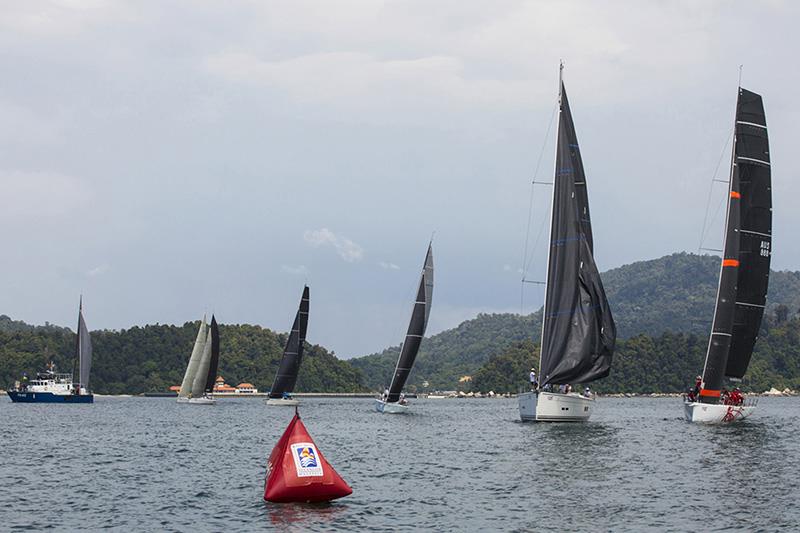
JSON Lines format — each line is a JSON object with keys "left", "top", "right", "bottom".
{"left": 264, "top": 412, "right": 353, "bottom": 503}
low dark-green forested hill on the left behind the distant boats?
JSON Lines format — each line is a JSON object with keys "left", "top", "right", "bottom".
{"left": 0, "top": 322, "right": 365, "bottom": 394}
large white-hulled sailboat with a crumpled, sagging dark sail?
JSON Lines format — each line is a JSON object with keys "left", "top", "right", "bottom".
{"left": 518, "top": 64, "right": 617, "bottom": 422}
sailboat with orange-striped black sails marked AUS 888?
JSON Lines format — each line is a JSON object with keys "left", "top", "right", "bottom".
{"left": 684, "top": 87, "right": 772, "bottom": 423}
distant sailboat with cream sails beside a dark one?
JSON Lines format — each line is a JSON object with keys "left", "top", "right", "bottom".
{"left": 178, "top": 315, "right": 219, "bottom": 405}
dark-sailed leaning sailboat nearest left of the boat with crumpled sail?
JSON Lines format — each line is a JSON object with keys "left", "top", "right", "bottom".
{"left": 375, "top": 243, "right": 433, "bottom": 413}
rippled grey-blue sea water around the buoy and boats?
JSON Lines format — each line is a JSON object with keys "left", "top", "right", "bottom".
{"left": 0, "top": 392, "right": 800, "bottom": 531}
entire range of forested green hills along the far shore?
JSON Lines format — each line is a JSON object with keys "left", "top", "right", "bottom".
{"left": 0, "top": 253, "right": 800, "bottom": 393}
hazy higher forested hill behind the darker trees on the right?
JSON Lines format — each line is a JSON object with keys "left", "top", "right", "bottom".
{"left": 350, "top": 253, "right": 800, "bottom": 389}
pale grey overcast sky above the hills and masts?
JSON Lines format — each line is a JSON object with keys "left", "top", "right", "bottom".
{"left": 0, "top": 0, "right": 800, "bottom": 357}
